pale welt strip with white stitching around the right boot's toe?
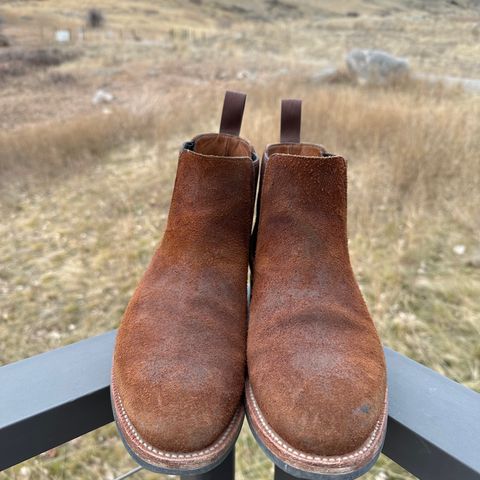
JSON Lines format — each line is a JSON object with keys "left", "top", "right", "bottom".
{"left": 246, "top": 383, "right": 387, "bottom": 466}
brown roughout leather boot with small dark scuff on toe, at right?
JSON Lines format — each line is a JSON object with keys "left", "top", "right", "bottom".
{"left": 246, "top": 100, "right": 387, "bottom": 480}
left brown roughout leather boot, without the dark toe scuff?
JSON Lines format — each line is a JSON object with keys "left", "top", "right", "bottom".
{"left": 111, "top": 92, "right": 257, "bottom": 475}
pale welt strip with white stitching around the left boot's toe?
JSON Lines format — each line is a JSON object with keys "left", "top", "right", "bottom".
{"left": 111, "top": 382, "right": 242, "bottom": 461}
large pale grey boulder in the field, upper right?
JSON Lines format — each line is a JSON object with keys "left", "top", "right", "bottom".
{"left": 346, "top": 49, "right": 410, "bottom": 85}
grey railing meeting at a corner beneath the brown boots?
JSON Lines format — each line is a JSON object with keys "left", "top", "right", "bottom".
{"left": 0, "top": 331, "right": 480, "bottom": 480}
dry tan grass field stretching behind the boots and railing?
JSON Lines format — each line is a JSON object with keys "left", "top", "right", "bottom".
{"left": 0, "top": 0, "right": 480, "bottom": 480}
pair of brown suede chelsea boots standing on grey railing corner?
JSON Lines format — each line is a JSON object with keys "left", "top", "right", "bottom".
{"left": 111, "top": 92, "right": 387, "bottom": 480}
